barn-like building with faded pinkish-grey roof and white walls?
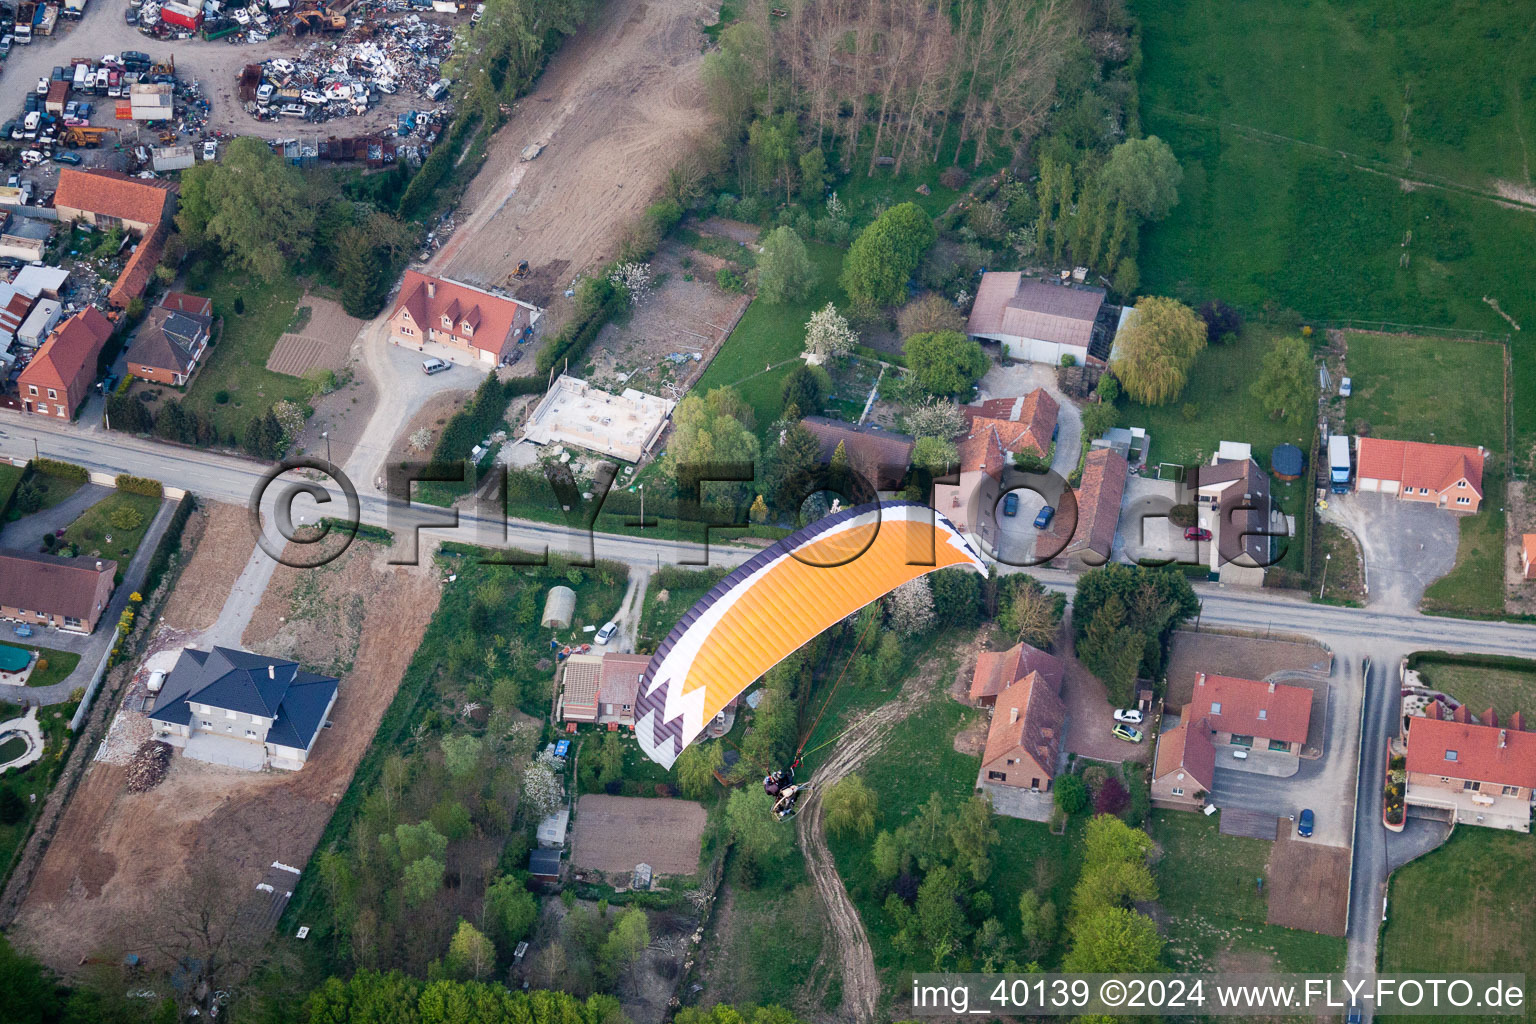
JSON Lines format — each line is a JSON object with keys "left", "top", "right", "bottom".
{"left": 966, "top": 272, "right": 1121, "bottom": 365}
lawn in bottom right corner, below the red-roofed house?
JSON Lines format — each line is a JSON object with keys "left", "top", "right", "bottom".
{"left": 1381, "top": 827, "right": 1536, "bottom": 1022}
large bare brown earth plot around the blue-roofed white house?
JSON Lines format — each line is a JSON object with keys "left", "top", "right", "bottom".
{"left": 12, "top": 543, "right": 439, "bottom": 972}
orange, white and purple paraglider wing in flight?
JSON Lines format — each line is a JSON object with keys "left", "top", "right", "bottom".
{"left": 634, "top": 502, "right": 986, "bottom": 768}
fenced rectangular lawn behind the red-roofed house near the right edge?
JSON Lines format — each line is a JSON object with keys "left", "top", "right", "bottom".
{"left": 1344, "top": 332, "right": 1504, "bottom": 451}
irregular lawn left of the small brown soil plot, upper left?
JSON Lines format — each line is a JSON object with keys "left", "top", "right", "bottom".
{"left": 183, "top": 270, "right": 309, "bottom": 444}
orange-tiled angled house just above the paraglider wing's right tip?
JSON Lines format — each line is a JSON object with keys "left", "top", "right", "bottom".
{"left": 934, "top": 388, "right": 1061, "bottom": 542}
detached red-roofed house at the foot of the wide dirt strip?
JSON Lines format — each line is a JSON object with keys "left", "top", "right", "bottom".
{"left": 389, "top": 270, "right": 539, "bottom": 365}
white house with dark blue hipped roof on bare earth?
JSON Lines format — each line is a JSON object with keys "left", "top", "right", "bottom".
{"left": 149, "top": 646, "right": 336, "bottom": 771}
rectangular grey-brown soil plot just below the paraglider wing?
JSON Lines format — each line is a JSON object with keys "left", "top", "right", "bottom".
{"left": 571, "top": 794, "right": 705, "bottom": 875}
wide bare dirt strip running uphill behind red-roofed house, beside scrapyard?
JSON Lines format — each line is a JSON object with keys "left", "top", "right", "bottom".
{"left": 430, "top": 0, "right": 716, "bottom": 306}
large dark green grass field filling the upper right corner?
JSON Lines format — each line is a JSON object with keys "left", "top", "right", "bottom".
{"left": 1132, "top": 0, "right": 1536, "bottom": 463}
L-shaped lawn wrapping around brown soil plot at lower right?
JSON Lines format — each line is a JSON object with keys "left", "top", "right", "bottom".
{"left": 1149, "top": 811, "right": 1344, "bottom": 972}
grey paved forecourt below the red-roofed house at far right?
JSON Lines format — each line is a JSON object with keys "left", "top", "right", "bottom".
{"left": 1322, "top": 494, "right": 1461, "bottom": 611}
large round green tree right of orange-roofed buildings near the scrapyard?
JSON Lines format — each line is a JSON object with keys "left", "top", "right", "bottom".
{"left": 177, "top": 137, "right": 315, "bottom": 281}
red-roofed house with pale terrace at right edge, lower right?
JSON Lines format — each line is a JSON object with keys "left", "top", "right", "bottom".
{"left": 1404, "top": 703, "right": 1536, "bottom": 832}
